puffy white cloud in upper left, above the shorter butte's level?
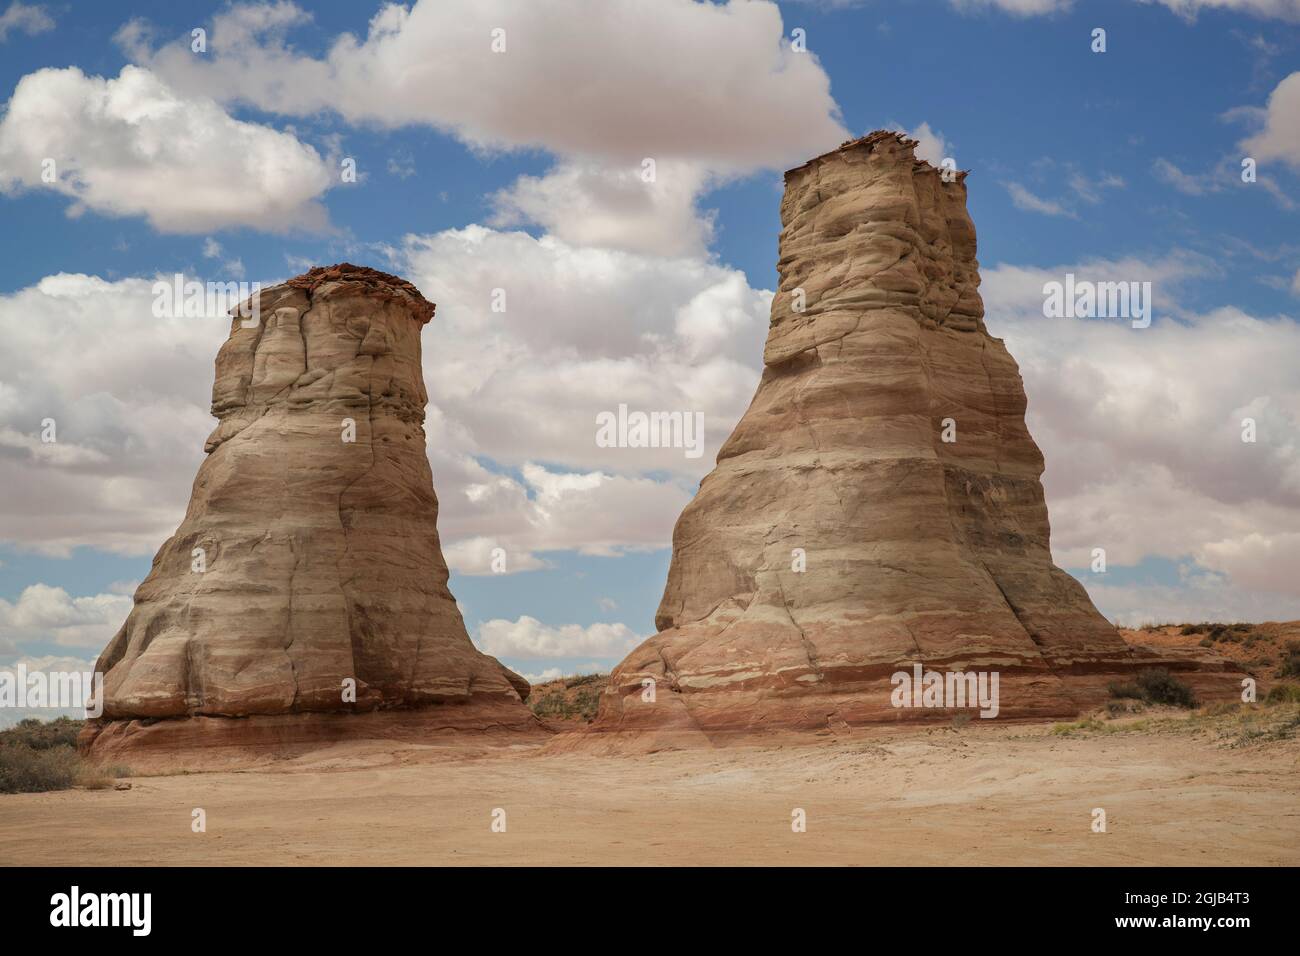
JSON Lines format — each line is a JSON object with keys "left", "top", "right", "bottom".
{"left": 0, "top": 66, "right": 332, "bottom": 233}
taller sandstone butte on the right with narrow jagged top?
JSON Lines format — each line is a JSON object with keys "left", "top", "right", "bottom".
{"left": 593, "top": 131, "right": 1236, "bottom": 749}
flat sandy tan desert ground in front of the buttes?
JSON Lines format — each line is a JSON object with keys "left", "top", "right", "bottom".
{"left": 0, "top": 705, "right": 1300, "bottom": 866}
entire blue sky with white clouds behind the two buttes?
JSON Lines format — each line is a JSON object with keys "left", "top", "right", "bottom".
{"left": 0, "top": 0, "right": 1300, "bottom": 702}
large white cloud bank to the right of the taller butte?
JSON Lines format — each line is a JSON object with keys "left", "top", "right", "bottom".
{"left": 983, "top": 254, "right": 1300, "bottom": 613}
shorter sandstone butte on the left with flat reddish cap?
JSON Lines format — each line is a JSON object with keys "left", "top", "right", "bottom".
{"left": 82, "top": 263, "right": 538, "bottom": 765}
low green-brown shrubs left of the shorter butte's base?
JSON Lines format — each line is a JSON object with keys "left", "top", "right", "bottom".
{"left": 0, "top": 717, "right": 130, "bottom": 793}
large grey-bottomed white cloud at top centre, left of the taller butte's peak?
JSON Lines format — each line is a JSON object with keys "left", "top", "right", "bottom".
{"left": 120, "top": 0, "right": 846, "bottom": 255}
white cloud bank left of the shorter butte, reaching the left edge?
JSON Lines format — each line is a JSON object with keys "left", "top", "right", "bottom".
{"left": 0, "top": 274, "right": 230, "bottom": 555}
